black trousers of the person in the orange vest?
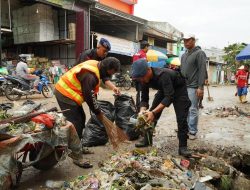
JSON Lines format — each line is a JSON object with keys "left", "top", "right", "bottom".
{"left": 57, "top": 99, "right": 86, "bottom": 139}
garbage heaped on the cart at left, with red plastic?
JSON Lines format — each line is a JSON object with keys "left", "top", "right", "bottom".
{"left": 0, "top": 100, "right": 66, "bottom": 137}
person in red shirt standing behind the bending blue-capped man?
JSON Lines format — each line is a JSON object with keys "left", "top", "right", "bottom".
{"left": 133, "top": 41, "right": 150, "bottom": 110}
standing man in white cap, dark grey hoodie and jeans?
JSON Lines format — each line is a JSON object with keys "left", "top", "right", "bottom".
{"left": 181, "top": 35, "right": 207, "bottom": 140}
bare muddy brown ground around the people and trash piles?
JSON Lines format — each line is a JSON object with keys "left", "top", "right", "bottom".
{"left": 0, "top": 86, "right": 250, "bottom": 190}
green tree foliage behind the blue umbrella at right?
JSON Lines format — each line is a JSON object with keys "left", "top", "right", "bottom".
{"left": 223, "top": 43, "right": 249, "bottom": 72}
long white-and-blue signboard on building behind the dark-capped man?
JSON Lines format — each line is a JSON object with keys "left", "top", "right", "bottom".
{"left": 95, "top": 33, "right": 139, "bottom": 56}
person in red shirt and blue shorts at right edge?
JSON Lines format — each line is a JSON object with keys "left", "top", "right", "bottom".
{"left": 236, "top": 65, "right": 249, "bottom": 103}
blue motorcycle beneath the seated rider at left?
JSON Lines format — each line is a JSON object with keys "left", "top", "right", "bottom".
{"left": 5, "top": 71, "right": 53, "bottom": 101}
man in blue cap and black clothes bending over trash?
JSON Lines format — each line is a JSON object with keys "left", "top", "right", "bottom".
{"left": 131, "top": 59, "right": 191, "bottom": 157}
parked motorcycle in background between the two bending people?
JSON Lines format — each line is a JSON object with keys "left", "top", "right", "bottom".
{"left": 111, "top": 73, "right": 132, "bottom": 90}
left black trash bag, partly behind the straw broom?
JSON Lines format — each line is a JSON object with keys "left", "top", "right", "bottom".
{"left": 82, "top": 101, "right": 115, "bottom": 147}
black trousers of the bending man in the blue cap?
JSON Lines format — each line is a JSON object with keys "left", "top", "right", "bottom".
{"left": 150, "top": 87, "right": 191, "bottom": 147}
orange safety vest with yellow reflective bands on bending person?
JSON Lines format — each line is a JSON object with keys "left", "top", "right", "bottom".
{"left": 55, "top": 60, "right": 100, "bottom": 105}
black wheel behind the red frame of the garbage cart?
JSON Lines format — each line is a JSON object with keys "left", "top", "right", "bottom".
{"left": 29, "top": 144, "right": 62, "bottom": 171}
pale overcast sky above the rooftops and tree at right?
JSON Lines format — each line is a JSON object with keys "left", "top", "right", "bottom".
{"left": 135, "top": 0, "right": 250, "bottom": 48}
